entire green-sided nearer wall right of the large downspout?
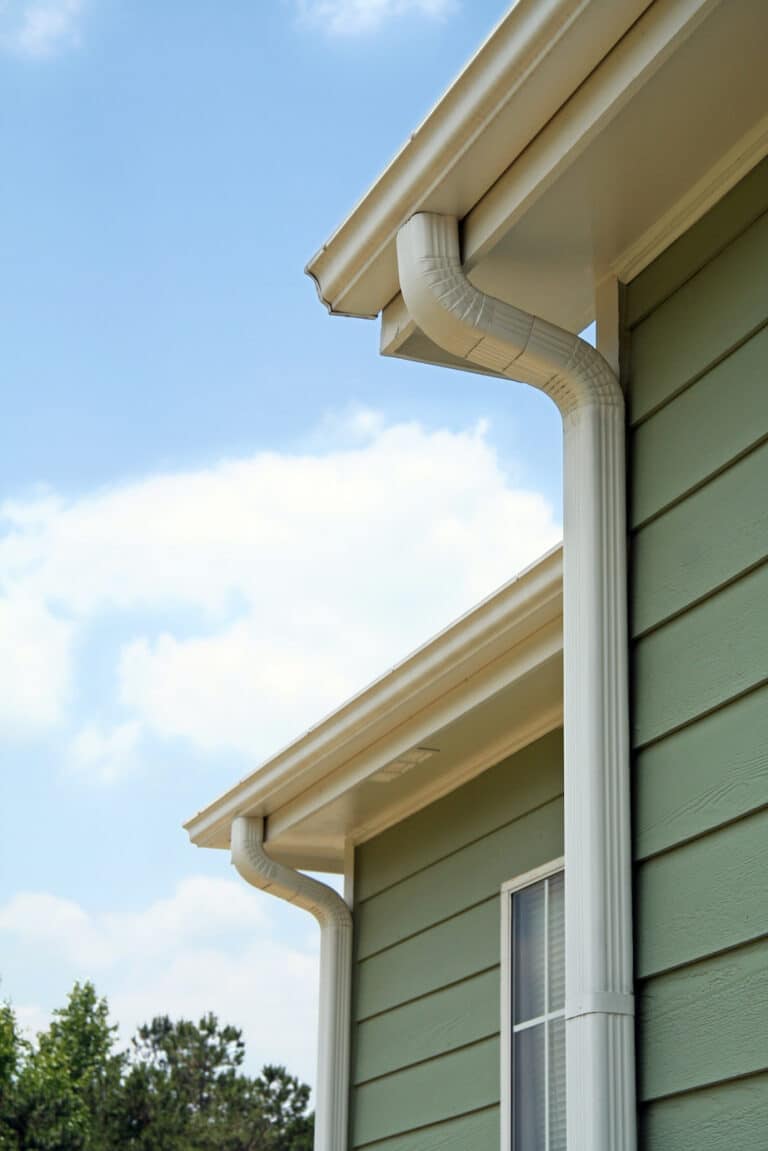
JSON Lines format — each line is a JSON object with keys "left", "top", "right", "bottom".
{"left": 624, "top": 161, "right": 768, "bottom": 1151}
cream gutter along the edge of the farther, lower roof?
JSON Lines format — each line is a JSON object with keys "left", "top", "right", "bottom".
{"left": 184, "top": 544, "right": 563, "bottom": 847}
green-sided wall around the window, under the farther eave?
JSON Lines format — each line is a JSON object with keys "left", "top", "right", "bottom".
{"left": 350, "top": 731, "right": 563, "bottom": 1151}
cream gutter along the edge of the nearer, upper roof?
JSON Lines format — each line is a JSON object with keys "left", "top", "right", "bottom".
{"left": 306, "top": 0, "right": 652, "bottom": 318}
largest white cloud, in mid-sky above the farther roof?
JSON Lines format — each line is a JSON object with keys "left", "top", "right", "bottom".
{"left": 0, "top": 412, "right": 560, "bottom": 780}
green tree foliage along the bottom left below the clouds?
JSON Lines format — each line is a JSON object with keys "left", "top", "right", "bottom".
{"left": 0, "top": 983, "right": 313, "bottom": 1151}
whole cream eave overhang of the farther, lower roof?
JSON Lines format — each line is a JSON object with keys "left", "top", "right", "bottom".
{"left": 185, "top": 548, "right": 563, "bottom": 871}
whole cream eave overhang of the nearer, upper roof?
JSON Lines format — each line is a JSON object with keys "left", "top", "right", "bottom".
{"left": 306, "top": 0, "right": 768, "bottom": 347}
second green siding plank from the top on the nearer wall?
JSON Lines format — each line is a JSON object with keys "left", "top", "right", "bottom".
{"left": 630, "top": 207, "right": 768, "bottom": 424}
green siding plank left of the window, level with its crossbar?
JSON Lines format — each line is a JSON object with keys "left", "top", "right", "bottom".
{"left": 355, "top": 968, "right": 500, "bottom": 1083}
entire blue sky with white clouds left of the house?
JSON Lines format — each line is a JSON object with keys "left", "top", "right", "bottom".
{"left": 0, "top": 0, "right": 561, "bottom": 1078}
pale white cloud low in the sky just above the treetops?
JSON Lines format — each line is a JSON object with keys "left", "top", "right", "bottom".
{"left": 0, "top": 877, "right": 318, "bottom": 1080}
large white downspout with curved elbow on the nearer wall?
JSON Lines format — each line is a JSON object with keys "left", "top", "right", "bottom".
{"left": 397, "top": 213, "right": 637, "bottom": 1151}
